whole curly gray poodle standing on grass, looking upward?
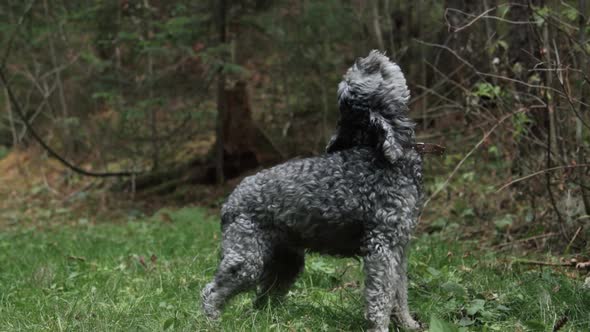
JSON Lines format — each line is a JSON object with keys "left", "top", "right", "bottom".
{"left": 202, "top": 51, "right": 423, "bottom": 331}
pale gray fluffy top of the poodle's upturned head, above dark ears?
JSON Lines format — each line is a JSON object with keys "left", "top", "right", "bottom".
{"left": 338, "top": 50, "right": 410, "bottom": 113}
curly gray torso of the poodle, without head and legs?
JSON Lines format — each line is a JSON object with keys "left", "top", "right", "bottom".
{"left": 221, "top": 147, "right": 422, "bottom": 256}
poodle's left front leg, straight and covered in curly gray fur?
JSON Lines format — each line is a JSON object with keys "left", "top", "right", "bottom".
{"left": 363, "top": 244, "right": 400, "bottom": 332}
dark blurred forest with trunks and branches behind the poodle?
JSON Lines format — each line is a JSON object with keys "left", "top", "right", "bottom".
{"left": 0, "top": 0, "right": 590, "bottom": 251}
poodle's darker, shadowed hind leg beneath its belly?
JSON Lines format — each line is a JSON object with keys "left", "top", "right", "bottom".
{"left": 254, "top": 245, "right": 305, "bottom": 307}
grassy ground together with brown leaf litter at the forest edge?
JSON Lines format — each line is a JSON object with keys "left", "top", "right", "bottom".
{"left": 0, "top": 149, "right": 590, "bottom": 332}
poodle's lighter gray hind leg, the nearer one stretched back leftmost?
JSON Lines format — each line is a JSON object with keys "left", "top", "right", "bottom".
{"left": 201, "top": 217, "right": 271, "bottom": 319}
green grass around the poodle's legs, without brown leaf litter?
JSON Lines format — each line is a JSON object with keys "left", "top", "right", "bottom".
{"left": 0, "top": 208, "right": 590, "bottom": 331}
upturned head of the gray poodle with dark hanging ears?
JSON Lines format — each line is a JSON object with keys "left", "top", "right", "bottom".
{"left": 328, "top": 50, "right": 414, "bottom": 163}
